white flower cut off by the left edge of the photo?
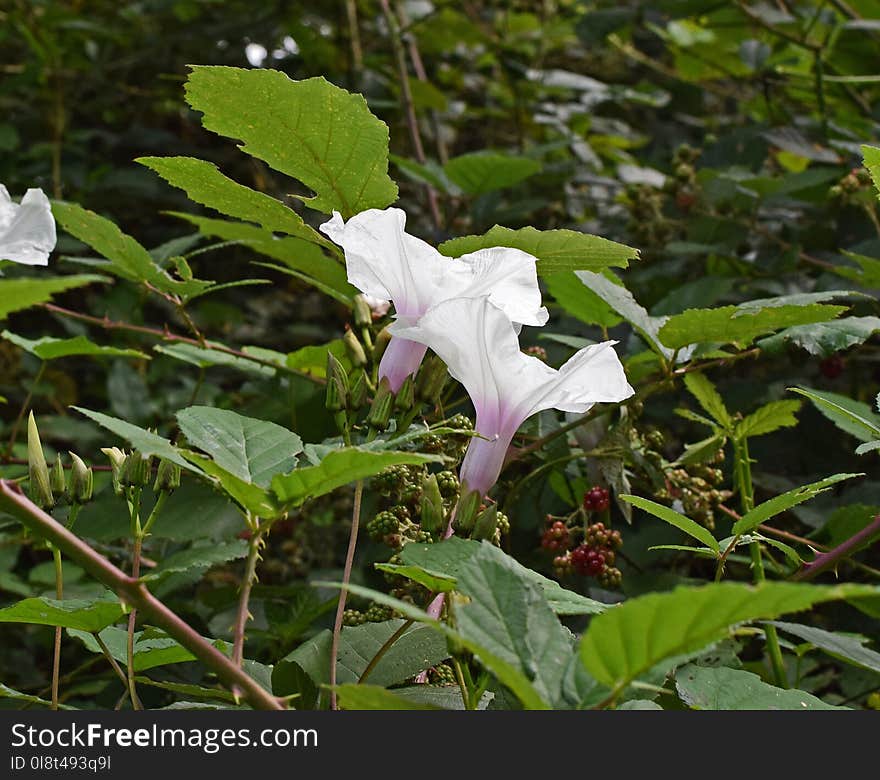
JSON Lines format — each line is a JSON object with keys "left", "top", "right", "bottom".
{"left": 0, "top": 184, "right": 56, "bottom": 265}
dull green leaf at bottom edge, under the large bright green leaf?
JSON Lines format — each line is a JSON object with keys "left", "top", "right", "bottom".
{"left": 675, "top": 664, "right": 848, "bottom": 710}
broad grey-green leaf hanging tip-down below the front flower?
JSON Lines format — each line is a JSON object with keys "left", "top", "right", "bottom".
{"left": 455, "top": 542, "right": 572, "bottom": 703}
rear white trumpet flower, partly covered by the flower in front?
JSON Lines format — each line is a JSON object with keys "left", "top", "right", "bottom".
{"left": 321, "top": 208, "right": 547, "bottom": 392}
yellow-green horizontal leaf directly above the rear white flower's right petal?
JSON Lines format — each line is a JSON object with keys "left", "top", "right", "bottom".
{"left": 439, "top": 225, "right": 639, "bottom": 276}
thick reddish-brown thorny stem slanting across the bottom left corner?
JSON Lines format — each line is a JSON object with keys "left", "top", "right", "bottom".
{"left": 0, "top": 479, "right": 284, "bottom": 710}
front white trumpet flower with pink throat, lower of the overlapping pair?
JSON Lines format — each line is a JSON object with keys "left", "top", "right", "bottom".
{"left": 390, "top": 297, "right": 633, "bottom": 495}
